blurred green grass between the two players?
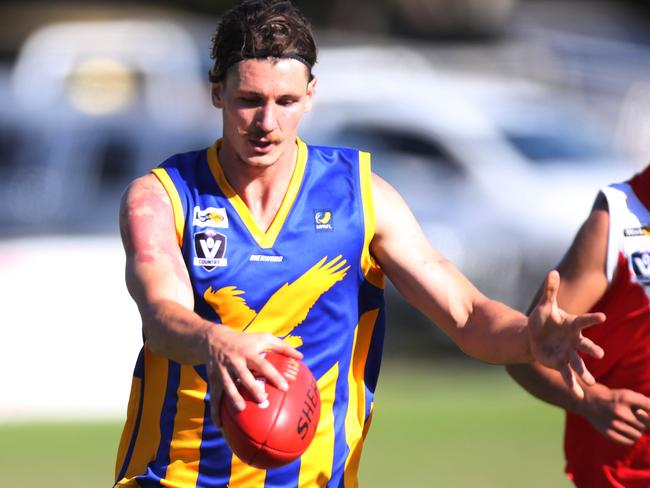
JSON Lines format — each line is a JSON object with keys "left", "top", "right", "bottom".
{"left": 360, "top": 359, "right": 572, "bottom": 488}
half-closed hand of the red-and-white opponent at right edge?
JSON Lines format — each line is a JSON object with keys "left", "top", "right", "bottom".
{"left": 579, "top": 384, "right": 650, "bottom": 446}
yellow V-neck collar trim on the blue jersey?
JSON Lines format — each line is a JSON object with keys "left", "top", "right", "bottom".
{"left": 208, "top": 138, "right": 308, "bottom": 249}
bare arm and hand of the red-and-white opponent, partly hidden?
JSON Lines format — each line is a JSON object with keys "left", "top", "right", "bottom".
{"left": 506, "top": 195, "right": 650, "bottom": 444}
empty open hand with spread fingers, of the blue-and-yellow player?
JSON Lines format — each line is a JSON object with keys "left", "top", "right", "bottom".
{"left": 528, "top": 270, "right": 605, "bottom": 398}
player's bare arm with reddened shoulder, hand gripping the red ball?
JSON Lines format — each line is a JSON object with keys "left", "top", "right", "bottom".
{"left": 120, "top": 174, "right": 301, "bottom": 419}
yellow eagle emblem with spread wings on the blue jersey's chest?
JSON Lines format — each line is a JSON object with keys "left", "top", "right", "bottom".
{"left": 203, "top": 256, "right": 350, "bottom": 347}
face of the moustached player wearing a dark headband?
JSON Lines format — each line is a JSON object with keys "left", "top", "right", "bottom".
{"left": 212, "top": 59, "right": 316, "bottom": 167}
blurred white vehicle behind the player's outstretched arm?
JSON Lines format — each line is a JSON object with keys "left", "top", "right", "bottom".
{"left": 303, "top": 47, "right": 638, "bottom": 307}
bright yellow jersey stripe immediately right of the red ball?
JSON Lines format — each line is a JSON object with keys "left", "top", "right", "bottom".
{"left": 298, "top": 363, "right": 339, "bottom": 488}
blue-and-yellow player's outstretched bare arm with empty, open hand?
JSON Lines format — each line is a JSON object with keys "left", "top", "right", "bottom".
{"left": 371, "top": 171, "right": 603, "bottom": 388}
